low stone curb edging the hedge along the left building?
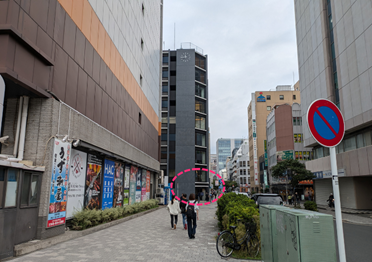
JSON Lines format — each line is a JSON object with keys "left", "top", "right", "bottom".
{"left": 13, "top": 206, "right": 164, "bottom": 257}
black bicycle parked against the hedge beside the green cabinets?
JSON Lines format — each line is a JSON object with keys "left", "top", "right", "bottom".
{"left": 216, "top": 219, "right": 260, "bottom": 258}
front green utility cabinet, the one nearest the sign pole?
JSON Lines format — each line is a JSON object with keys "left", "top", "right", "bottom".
{"left": 276, "top": 209, "right": 337, "bottom": 262}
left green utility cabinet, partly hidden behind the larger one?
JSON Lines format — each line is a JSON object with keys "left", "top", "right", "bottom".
{"left": 260, "top": 205, "right": 290, "bottom": 262}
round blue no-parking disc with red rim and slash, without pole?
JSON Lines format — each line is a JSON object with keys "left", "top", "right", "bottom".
{"left": 307, "top": 98, "right": 345, "bottom": 147}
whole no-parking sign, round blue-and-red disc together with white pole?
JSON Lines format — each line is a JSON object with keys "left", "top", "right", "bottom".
{"left": 306, "top": 99, "right": 346, "bottom": 262}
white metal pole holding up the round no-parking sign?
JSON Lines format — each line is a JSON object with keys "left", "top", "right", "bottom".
{"left": 329, "top": 146, "right": 346, "bottom": 262}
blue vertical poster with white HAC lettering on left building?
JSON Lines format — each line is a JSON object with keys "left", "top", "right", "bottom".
{"left": 102, "top": 159, "right": 115, "bottom": 210}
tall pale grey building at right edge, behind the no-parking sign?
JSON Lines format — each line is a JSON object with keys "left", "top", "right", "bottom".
{"left": 295, "top": 0, "right": 372, "bottom": 209}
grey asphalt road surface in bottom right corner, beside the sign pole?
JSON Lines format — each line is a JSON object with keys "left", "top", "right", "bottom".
{"left": 335, "top": 221, "right": 372, "bottom": 262}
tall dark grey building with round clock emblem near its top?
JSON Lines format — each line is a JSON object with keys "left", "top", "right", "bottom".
{"left": 160, "top": 48, "right": 209, "bottom": 196}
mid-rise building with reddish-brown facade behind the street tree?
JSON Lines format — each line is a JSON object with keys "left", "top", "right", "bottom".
{"left": 266, "top": 103, "right": 311, "bottom": 198}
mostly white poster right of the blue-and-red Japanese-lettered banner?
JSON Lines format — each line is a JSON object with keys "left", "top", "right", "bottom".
{"left": 66, "top": 149, "right": 87, "bottom": 219}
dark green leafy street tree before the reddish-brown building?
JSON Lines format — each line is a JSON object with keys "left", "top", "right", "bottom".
{"left": 271, "top": 159, "right": 315, "bottom": 188}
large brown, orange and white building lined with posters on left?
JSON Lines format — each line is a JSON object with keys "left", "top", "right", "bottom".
{"left": 0, "top": 0, "right": 162, "bottom": 260}
